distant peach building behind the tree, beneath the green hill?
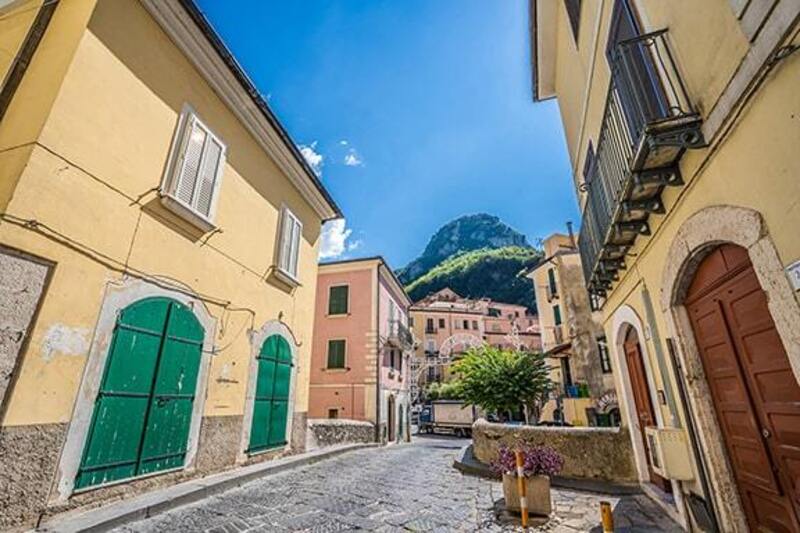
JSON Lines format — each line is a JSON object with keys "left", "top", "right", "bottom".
{"left": 410, "top": 288, "right": 542, "bottom": 386}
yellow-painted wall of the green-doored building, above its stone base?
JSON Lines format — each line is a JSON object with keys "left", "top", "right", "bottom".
{"left": 0, "top": 0, "right": 321, "bottom": 425}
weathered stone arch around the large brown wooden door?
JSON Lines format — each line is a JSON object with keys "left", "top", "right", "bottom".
{"left": 661, "top": 205, "right": 800, "bottom": 531}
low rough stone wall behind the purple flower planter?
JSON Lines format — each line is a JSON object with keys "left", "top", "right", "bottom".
{"left": 472, "top": 419, "right": 637, "bottom": 483}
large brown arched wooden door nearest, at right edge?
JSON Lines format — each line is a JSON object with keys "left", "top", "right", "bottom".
{"left": 686, "top": 245, "right": 800, "bottom": 533}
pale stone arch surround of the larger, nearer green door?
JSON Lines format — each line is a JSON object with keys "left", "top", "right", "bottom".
{"left": 51, "top": 278, "right": 217, "bottom": 503}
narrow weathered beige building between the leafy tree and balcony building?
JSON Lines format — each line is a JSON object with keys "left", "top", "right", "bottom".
{"left": 527, "top": 233, "right": 620, "bottom": 426}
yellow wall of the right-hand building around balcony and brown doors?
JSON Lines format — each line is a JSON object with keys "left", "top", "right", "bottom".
{"left": 539, "top": 0, "right": 800, "bottom": 516}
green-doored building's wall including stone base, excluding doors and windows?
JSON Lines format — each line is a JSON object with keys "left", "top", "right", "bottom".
{"left": 0, "top": 0, "right": 328, "bottom": 529}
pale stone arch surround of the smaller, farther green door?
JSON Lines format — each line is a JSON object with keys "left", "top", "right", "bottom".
{"left": 236, "top": 320, "right": 305, "bottom": 463}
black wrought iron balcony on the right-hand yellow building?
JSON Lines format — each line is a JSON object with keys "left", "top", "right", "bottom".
{"left": 578, "top": 30, "right": 705, "bottom": 297}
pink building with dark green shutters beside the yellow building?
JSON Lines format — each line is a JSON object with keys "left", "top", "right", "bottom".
{"left": 308, "top": 257, "right": 413, "bottom": 442}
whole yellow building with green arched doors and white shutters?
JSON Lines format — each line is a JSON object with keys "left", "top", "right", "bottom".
{"left": 0, "top": 0, "right": 340, "bottom": 530}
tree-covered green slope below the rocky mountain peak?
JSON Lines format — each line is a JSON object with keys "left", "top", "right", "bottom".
{"left": 406, "top": 246, "right": 542, "bottom": 310}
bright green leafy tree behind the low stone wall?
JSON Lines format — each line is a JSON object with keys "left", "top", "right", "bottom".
{"left": 453, "top": 346, "right": 552, "bottom": 421}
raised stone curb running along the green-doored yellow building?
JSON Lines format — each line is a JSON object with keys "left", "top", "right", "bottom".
{"left": 41, "top": 443, "right": 377, "bottom": 533}
